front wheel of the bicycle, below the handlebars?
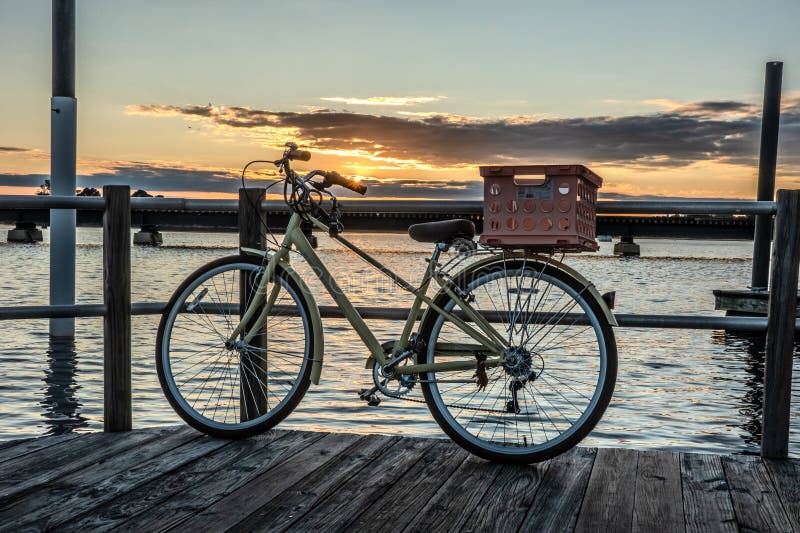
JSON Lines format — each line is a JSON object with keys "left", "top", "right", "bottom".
{"left": 156, "top": 256, "right": 313, "bottom": 438}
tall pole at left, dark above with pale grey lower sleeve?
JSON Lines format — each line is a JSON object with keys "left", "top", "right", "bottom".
{"left": 50, "top": 0, "right": 78, "bottom": 337}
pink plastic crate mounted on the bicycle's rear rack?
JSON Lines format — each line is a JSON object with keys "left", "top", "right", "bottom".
{"left": 480, "top": 165, "right": 603, "bottom": 252}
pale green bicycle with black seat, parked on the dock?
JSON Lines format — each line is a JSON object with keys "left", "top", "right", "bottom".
{"left": 156, "top": 143, "right": 617, "bottom": 463}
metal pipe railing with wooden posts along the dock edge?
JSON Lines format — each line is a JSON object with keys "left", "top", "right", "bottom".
{"left": 0, "top": 187, "right": 800, "bottom": 457}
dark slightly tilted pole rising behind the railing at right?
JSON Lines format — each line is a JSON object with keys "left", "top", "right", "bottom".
{"left": 750, "top": 61, "right": 783, "bottom": 290}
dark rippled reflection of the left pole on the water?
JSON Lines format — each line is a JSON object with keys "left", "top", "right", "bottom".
{"left": 39, "top": 337, "right": 89, "bottom": 435}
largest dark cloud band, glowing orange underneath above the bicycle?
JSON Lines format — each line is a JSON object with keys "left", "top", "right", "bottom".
{"left": 128, "top": 96, "right": 800, "bottom": 172}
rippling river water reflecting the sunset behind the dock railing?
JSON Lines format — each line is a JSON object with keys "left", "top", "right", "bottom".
{"left": 0, "top": 227, "right": 800, "bottom": 455}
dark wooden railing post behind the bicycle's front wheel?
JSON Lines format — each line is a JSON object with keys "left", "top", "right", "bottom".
{"left": 239, "top": 188, "right": 269, "bottom": 421}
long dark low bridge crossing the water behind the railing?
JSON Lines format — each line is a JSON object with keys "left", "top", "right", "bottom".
{"left": 0, "top": 197, "right": 754, "bottom": 239}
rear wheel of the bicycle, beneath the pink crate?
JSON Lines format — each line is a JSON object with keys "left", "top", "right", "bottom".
{"left": 421, "top": 258, "right": 617, "bottom": 463}
